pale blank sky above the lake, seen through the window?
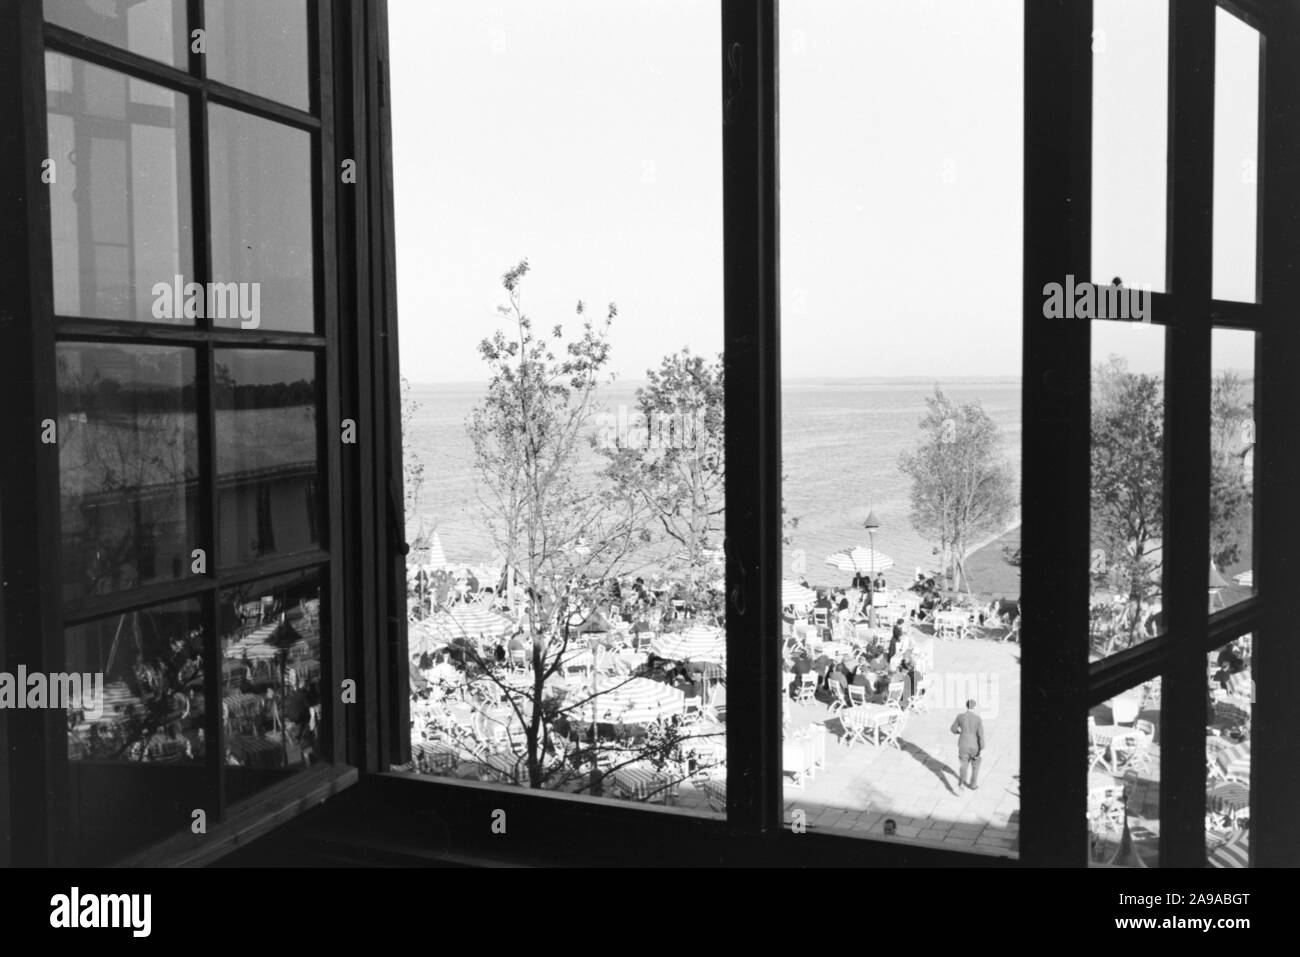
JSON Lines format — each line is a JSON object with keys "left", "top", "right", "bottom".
{"left": 389, "top": 0, "right": 1258, "bottom": 382}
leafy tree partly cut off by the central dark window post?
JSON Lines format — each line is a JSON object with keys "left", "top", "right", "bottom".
{"left": 595, "top": 350, "right": 727, "bottom": 605}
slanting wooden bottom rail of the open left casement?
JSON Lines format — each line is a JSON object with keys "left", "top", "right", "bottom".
{"left": 114, "top": 765, "right": 359, "bottom": 867}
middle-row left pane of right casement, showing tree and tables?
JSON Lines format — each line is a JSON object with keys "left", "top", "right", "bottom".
{"left": 1088, "top": 321, "right": 1165, "bottom": 661}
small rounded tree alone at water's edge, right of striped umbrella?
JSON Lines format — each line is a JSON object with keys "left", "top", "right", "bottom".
{"left": 898, "top": 385, "right": 1015, "bottom": 589}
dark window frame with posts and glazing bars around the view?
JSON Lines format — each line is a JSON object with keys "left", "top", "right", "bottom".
{"left": 0, "top": 0, "right": 1300, "bottom": 867}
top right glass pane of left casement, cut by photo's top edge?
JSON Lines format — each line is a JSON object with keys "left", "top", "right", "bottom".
{"left": 203, "top": 0, "right": 312, "bottom": 109}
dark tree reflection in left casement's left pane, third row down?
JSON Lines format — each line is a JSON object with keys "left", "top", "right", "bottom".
{"left": 59, "top": 356, "right": 196, "bottom": 594}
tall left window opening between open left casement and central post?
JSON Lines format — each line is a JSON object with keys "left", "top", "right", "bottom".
{"left": 390, "top": 0, "right": 728, "bottom": 814}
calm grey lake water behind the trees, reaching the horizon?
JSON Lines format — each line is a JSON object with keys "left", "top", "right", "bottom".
{"left": 406, "top": 378, "right": 1021, "bottom": 585}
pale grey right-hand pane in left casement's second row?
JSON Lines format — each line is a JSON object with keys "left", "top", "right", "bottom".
{"left": 208, "top": 105, "right": 316, "bottom": 333}
